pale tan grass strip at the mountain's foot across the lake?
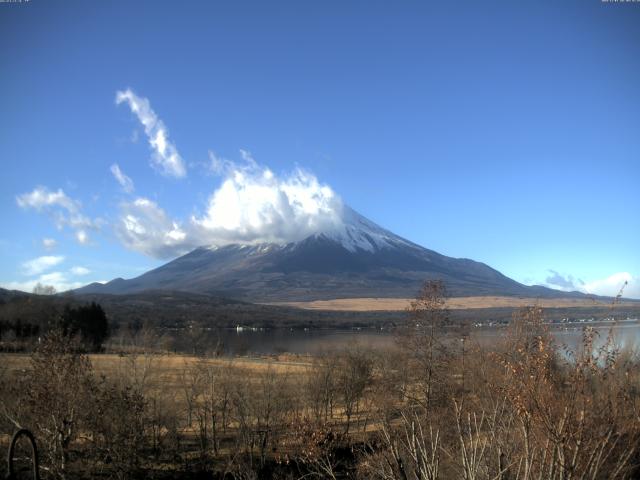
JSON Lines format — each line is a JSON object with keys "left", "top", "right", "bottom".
{"left": 270, "top": 297, "right": 637, "bottom": 312}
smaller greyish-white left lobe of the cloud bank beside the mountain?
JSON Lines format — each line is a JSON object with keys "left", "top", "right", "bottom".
{"left": 116, "top": 198, "right": 196, "bottom": 258}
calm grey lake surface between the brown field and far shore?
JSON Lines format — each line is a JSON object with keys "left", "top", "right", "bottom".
{"left": 180, "top": 320, "right": 640, "bottom": 355}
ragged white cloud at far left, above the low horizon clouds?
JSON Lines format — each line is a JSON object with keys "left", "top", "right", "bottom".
{"left": 16, "top": 186, "right": 101, "bottom": 244}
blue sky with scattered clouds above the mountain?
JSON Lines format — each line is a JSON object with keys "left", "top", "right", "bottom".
{"left": 0, "top": 0, "right": 640, "bottom": 298}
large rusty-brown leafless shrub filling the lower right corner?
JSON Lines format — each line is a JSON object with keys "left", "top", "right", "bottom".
{"left": 490, "top": 308, "right": 639, "bottom": 479}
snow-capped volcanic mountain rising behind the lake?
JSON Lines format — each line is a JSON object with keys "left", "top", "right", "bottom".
{"left": 75, "top": 206, "right": 582, "bottom": 302}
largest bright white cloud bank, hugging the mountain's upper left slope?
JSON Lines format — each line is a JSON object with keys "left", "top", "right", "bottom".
{"left": 116, "top": 156, "right": 342, "bottom": 258}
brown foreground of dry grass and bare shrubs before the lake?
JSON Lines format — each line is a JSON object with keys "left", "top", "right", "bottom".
{"left": 0, "top": 282, "right": 640, "bottom": 480}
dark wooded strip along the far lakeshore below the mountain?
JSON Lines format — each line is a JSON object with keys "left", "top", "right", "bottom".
{"left": 0, "top": 289, "right": 640, "bottom": 348}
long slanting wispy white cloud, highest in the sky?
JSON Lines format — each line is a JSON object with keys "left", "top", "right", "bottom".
{"left": 116, "top": 88, "right": 187, "bottom": 178}
